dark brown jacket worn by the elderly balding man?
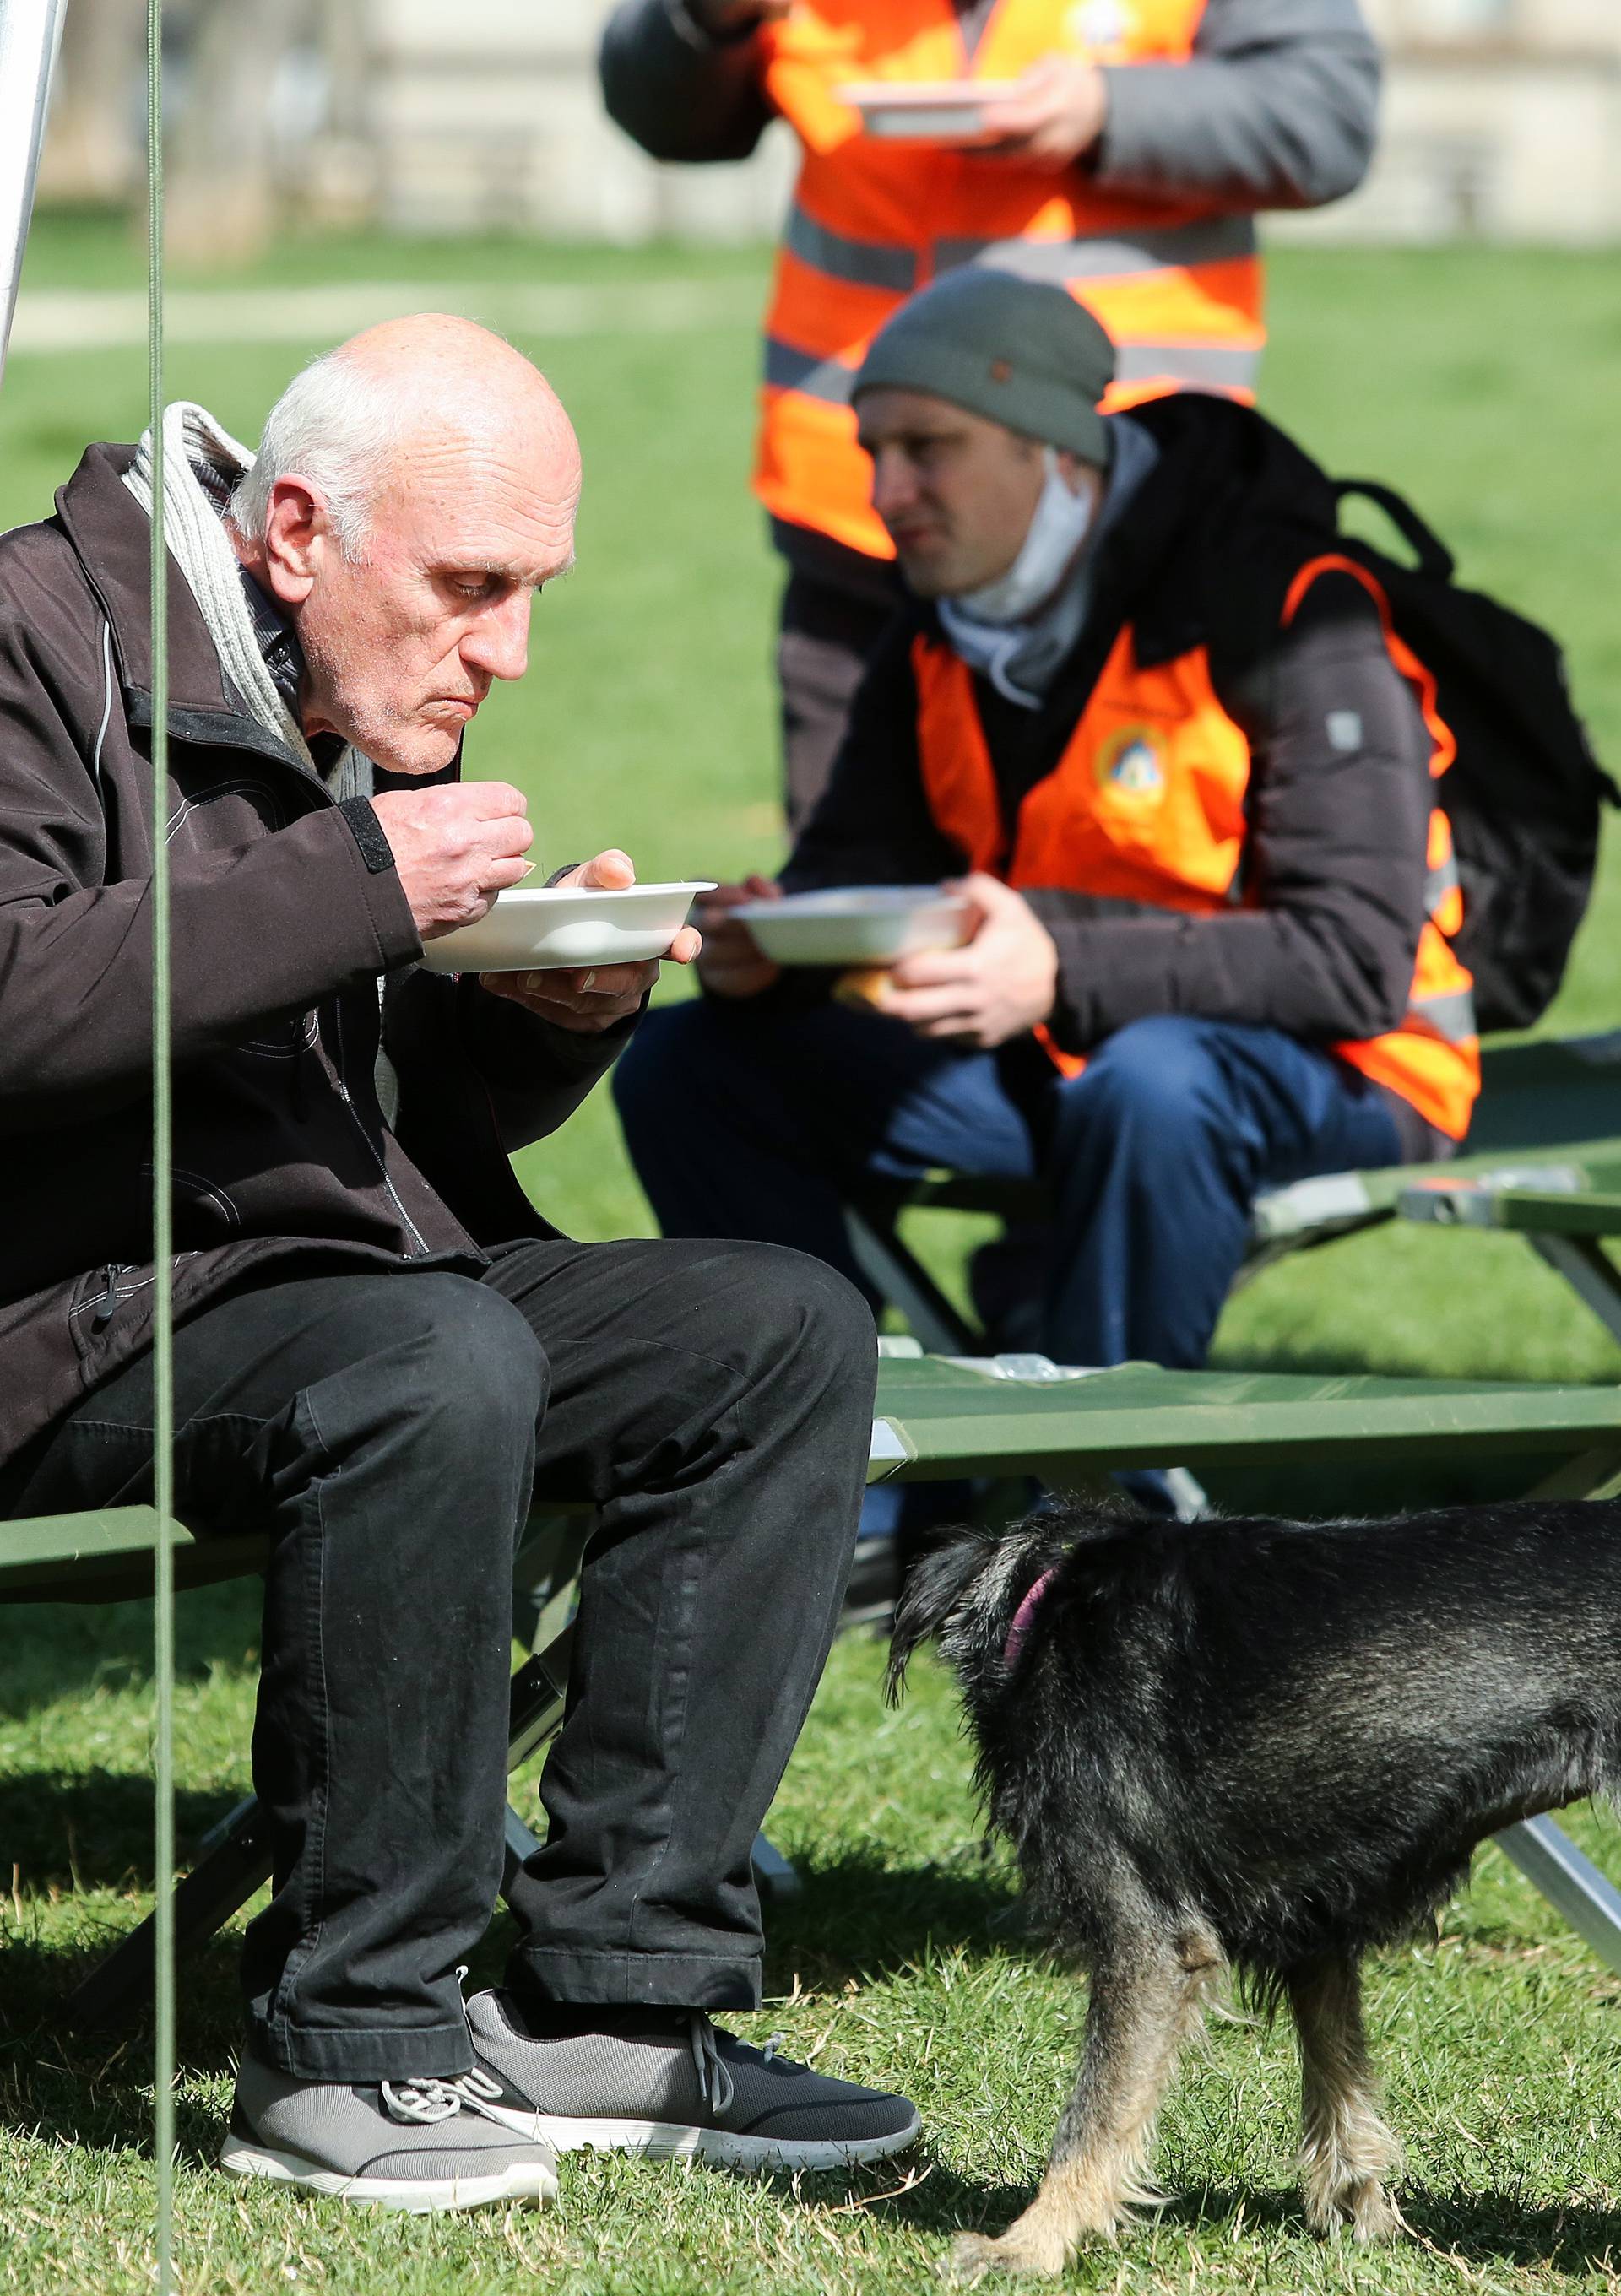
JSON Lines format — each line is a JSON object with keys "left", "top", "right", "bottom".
{"left": 0, "top": 446, "right": 625, "bottom": 1463}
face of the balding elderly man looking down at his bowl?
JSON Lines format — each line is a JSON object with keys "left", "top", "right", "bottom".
{"left": 281, "top": 425, "right": 578, "bottom": 774}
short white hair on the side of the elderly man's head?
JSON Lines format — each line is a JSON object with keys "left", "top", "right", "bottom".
{"left": 230, "top": 351, "right": 409, "bottom": 560}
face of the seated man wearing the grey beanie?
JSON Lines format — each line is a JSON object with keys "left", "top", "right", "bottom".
{"left": 856, "top": 388, "right": 1044, "bottom": 597}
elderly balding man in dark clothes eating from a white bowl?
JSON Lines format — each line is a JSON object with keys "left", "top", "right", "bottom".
{"left": 0, "top": 319, "right": 916, "bottom": 2209}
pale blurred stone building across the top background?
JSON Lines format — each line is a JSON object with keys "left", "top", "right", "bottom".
{"left": 44, "top": 0, "right": 1621, "bottom": 255}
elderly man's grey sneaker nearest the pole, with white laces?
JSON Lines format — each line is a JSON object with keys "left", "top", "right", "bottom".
{"left": 220, "top": 2057, "right": 558, "bottom": 2216}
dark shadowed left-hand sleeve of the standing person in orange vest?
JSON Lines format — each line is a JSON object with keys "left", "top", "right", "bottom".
{"left": 597, "top": 0, "right": 772, "bottom": 160}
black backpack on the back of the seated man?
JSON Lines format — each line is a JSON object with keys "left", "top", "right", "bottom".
{"left": 1334, "top": 478, "right": 1621, "bottom": 1031}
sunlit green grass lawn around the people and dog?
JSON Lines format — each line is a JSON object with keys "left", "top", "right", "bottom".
{"left": 0, "top": 225, "right": 1621, "bottom": 2296}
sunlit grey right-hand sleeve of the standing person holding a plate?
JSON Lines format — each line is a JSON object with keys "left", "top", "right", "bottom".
{"left": 1095, "top": 0, "right": 1380, "bottom": 209}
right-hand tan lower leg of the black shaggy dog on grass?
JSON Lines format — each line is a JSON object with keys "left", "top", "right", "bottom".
{"left": 1288, "top": 1956, "right": 1401, "bottom": 2241}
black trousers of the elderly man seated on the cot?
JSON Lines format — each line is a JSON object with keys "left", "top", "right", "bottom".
{"left": 4, "top": 1240, "right": 877, "bottom": 2080}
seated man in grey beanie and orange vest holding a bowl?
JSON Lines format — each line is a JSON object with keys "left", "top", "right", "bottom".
{"left": 615, "top": 271, "right": 1478, "bottom": 1395}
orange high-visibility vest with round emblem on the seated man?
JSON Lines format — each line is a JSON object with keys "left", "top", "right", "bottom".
{"left": 912, "top": 555, "right": 1481, "bottom": 1141}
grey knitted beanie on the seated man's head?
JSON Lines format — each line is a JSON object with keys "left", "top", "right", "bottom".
{"left": 852, "top": 264, "right": 1114, "bottom": 466}
